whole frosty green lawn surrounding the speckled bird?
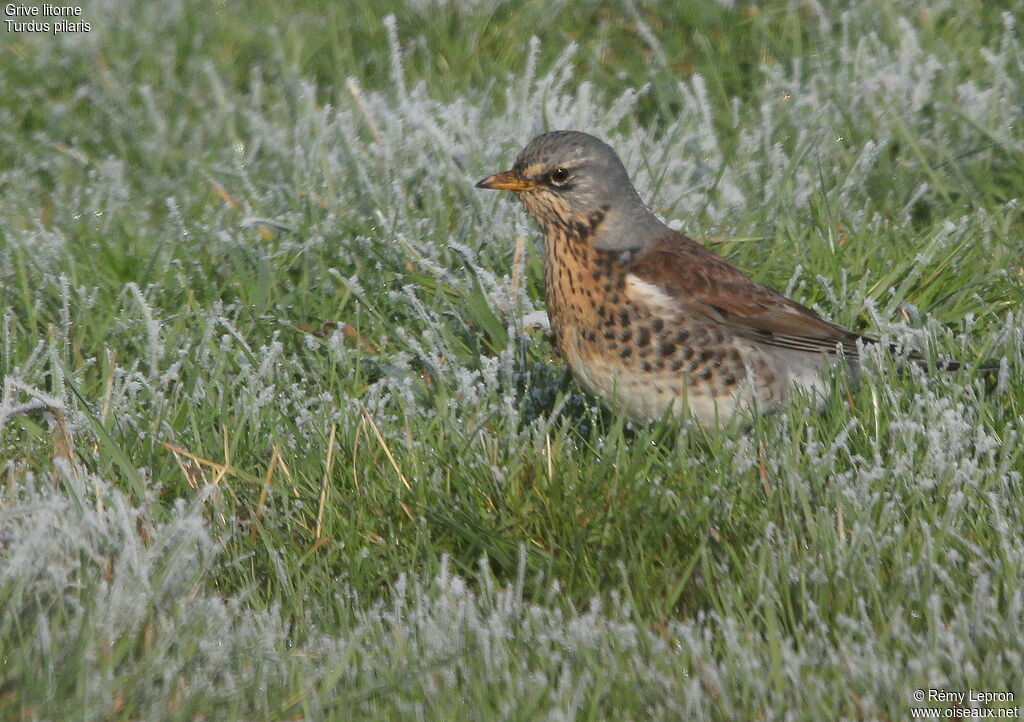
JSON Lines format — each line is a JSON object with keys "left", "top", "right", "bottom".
{"left": 0, "top": 0, "right": 1024, "bottom": 720}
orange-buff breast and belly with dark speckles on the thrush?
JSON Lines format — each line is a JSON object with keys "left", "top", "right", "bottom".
{"left": 545, "top": 235, "right": 765, "bottom": 418}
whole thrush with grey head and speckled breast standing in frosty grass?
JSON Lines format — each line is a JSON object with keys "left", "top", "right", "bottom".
{"left": 476, "top": 130, "right": 991, "bottom": 426}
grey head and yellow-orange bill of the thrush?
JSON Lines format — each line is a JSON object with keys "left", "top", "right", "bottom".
{"left": 476, "top": 130, "right": 667, "bottom": 251}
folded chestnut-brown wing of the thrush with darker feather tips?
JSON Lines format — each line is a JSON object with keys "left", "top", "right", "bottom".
{"left": 630, "top": 233, "right": 873, "bottom": 356}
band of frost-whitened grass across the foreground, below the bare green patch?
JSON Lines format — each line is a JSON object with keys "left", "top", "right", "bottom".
{"left": 0, "top": 464, "right": 1024, "bottom": 719}
